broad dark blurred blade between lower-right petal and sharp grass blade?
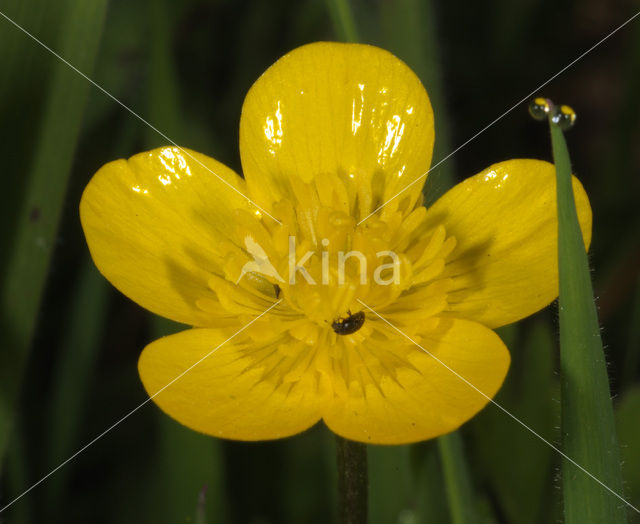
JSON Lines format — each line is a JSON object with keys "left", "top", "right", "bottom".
{"left": 466, "top": 319, "right": 560, "bottom": 524}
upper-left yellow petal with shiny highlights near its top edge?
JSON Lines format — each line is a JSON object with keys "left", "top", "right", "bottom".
{"left": 80, "top": 143, "right": 249, "bottom": 325}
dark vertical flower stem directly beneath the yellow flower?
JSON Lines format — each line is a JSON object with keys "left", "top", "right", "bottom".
{"left": 336, "top": 435, "right": 369, "bottom": 524}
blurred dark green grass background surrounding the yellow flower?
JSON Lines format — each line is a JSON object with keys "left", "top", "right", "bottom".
{"left": 0, "top": 0, "right": 640, "bottom": 524}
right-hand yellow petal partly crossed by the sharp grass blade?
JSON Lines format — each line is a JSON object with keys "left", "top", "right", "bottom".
{"left": 426, "top": 160, "right": 591, "bottom": 328}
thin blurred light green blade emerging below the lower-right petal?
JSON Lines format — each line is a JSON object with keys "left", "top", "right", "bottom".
{"left": 438, "top": 431, "right": 478, "bottom": 524}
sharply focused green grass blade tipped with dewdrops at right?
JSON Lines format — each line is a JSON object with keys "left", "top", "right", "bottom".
{"left": 550, "top": 123, "right": 626, "bottom": 524}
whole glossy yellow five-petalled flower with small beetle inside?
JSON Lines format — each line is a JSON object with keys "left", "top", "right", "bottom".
{"left": 80, "top": 43, "right": 591, "bottom": 444}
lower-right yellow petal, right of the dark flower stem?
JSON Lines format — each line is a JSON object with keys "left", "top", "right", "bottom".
{"left": 323, "top": 319, "right": 510, "bottom": 444}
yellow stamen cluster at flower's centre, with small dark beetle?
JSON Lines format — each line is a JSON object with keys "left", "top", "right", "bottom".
{"left": 199, "top": 176, "right": 455, "bottom": 398}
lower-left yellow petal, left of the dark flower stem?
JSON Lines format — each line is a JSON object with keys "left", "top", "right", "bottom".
{"left": 138, "top": 329, "right": 322, "bottom": 440}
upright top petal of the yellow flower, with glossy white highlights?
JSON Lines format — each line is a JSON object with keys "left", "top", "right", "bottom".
{"left": 240, "top": 42, "right": 434, "bottom": 217}
